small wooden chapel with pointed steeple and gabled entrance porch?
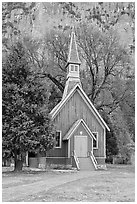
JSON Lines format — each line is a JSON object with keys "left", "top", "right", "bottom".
{"left": 46, "top": 29, "right": 109, "bottom": 170}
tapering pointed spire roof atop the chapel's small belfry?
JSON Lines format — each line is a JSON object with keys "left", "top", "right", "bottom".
{"left": 67, "top": 27, "right": 81, "bottom": 64}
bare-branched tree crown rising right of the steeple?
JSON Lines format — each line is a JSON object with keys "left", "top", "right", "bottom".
{"left": 77, "top": 24, "right": 130, "bottom": 111}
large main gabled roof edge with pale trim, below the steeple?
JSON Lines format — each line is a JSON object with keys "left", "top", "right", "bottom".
{"left": 50, "top": 84, "right": 110, "bottom": 131}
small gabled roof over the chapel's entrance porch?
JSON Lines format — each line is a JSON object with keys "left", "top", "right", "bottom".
{"left": 63, "top": 119, "right": 96, "bottom": 140}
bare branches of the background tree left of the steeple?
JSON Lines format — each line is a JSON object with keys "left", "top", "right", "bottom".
{"left": 24, "top": 30, "right": 70, "bottom": 93}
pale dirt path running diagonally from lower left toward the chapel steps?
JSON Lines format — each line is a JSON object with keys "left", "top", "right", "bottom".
{"left": 2, "top": 171, "right": 103, "bottom": 202}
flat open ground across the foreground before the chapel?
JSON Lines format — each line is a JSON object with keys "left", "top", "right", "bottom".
{"left": 2, "top": 165, "right": 135, "bottom": 202}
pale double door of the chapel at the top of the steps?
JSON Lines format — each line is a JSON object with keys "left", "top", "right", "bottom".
{"left": 74, "top": 136, "right": 88, "bottom": 157}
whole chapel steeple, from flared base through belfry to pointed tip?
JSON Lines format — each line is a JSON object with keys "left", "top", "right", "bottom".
{"left": 62, "top": 28, "right": 81, "bottom": 99}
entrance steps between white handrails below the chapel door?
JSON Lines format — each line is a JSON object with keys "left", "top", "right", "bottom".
{"left": 78, "top": 157, "right": 95, "bottom": 171}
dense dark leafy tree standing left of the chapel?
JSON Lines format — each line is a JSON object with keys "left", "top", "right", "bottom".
{"left": 2, "top": 42, "right": 55, "bottom": 171}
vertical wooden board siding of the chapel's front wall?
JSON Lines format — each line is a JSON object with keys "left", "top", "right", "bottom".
{"left": 50, "top": 90, "right": 104, "bottom": 157}
